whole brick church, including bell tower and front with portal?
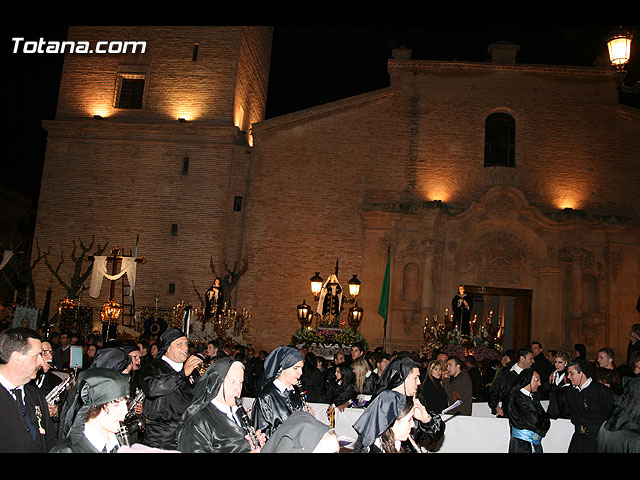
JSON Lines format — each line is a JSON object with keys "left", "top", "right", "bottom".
{"left": 35, "top": 27, "right": 640, "bottom": 354}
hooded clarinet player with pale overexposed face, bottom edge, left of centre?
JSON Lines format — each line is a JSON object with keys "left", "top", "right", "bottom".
{"left": 178, "top": 357, "right": 266, "bottom": 453}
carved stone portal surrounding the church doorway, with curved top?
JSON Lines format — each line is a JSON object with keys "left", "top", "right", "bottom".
{"left": 362, "top": 185, "right": 638, "bottom": 353}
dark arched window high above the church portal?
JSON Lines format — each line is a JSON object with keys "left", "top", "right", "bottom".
{"left": 484, "top": 113, "right": 516, "bottom": 167}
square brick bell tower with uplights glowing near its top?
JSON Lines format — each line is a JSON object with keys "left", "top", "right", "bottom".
{"left": 35, "top": 26, "right": 272, "bottom": 334}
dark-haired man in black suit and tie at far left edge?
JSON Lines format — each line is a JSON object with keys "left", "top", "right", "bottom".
{"left": 0, "top": 327, "right": 56, "bottom": 453}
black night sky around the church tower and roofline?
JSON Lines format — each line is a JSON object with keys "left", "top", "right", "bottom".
{"left": 0, "top": 22, "right": 640, "bottom": 208}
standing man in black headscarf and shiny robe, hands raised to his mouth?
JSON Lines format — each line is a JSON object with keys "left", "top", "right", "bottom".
{"left": 140, "top": 328, "right": 202, "bottom": 450}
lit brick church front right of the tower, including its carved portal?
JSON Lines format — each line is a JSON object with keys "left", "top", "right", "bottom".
{"left": 242, "top": 46, "right": 640, "bottom": 354}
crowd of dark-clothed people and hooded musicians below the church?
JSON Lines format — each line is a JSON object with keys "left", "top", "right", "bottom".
{"left": 0, "top": 324, "right": 640, "bottom": 453}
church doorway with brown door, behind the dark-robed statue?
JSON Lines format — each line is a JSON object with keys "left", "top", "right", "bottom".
{"left": 465, "top": 285, "right": 533, "bottom": 350}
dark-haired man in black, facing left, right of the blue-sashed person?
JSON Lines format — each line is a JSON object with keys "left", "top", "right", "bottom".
{"left": 565, "top": 359, "right": 615, "bottom": 453}
